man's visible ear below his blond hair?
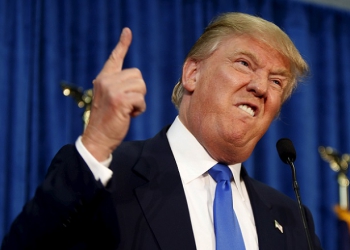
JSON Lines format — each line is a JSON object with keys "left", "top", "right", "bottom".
{"left": 182, "top": 58, "right": 198, "bottom": 92}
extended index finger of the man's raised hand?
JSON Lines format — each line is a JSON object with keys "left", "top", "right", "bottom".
{"left": 101, "top": 28, "right": 132, "bottom": 74}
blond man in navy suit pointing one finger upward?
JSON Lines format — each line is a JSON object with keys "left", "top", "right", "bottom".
{"left": 3, "top": 13, "right": 321, "bottom": 250}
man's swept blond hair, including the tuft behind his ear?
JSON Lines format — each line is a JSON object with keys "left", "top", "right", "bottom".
{"left": 172, "top": 12, "right": 309, "bottom": 108}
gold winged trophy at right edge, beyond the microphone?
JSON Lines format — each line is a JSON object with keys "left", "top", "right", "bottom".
{"left": 318, "top": 146, "right": 350, "bottom": 232}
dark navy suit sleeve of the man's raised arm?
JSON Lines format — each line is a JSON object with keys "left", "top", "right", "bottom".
{"left": 1, "top": 145, "right": 112, "bottom": 250}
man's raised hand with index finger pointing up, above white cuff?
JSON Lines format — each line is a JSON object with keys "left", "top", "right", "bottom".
{"left": 82, "top": 28, "right": 146, "bottom": 161}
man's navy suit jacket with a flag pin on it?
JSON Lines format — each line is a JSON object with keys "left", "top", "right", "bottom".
{"left": 1, "top": 127, "right": 321, "bottom": 250}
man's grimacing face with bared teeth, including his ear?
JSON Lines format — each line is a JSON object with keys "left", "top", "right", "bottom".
{"left": 180, "top": 35, "right": 290, "bottom": 164}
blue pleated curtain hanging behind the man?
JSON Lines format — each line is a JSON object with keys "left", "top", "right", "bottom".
{"left": 0, "top": 0, "right": 350, "bottom": 250}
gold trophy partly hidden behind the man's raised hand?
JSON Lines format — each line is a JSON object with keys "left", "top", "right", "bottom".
{"left": 61, "top": 82, "right": 92, "bottom": 129}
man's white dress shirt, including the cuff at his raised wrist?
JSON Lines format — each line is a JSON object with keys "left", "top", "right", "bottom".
{"left": 76, "top": 117, "right": 259, "bottom": 250}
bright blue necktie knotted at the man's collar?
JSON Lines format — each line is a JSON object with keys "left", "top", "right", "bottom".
{"left": 208, "top": 163, "right": 245, "bottom": 250}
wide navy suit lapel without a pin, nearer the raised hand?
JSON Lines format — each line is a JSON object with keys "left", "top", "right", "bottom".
{"left": 134, "top": 129, "right": 196, "bottom": 250}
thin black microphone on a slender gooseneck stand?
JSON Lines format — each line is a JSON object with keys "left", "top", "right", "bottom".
{"left": 276, "top": 138, "right": 314, "bottom": 250}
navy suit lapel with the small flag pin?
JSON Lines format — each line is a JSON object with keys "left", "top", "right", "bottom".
{"left": 242, "top": 167, "right": 287, "bottom": 250}
